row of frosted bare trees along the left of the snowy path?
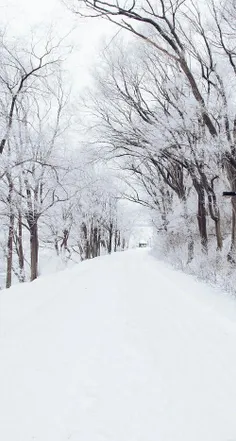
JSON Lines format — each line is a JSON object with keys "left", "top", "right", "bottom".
{"left": 0, "top": 29, "right": 130, "bottom": 288}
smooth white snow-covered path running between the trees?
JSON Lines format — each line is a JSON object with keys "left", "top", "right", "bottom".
{"left": 0, "top": 250, "right": 236, "bottom": 441}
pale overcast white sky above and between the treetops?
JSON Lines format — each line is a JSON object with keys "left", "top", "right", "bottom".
{"left": 0, "top": 0, "right": 117, "bottom": 88}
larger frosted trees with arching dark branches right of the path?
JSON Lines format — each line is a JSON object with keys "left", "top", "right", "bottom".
{"left": 71, "top": 0, "right": 236, "bottom": 263}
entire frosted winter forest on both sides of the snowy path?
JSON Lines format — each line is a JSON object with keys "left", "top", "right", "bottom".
{"left": 0, "top": 0, "right": 236, "bottom": 292}
